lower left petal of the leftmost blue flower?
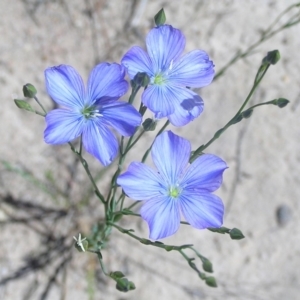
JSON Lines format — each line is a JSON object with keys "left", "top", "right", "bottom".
{"left": 44, "top": 109, "right": 85, "bottom": 145}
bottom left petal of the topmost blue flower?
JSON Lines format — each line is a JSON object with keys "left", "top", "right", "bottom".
{"left": 142, "top": 85, "right": 175, "bottom": 118}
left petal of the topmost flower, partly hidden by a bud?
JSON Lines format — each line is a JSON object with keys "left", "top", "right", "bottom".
{"left": 121, "top": 46, "right": 154, "bottom": 79}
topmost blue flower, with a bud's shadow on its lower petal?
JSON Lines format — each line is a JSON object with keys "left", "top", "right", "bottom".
{"left": 122, "top": 25, "right": 214, "bottom": 126}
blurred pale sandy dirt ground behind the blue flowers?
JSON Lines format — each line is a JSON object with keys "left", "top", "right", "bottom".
{"left": 0, "top": 0, "right": 300, "bottom": 300}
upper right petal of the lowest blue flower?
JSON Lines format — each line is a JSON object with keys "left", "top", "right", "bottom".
{"left": 181, "top": 154, "right": 227, "bottom": 192}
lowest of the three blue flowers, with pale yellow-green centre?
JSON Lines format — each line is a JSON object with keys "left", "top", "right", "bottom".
{"left": 117, "top": 131, "right": 227, "bottom": 240}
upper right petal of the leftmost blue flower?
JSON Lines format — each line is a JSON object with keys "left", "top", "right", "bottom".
{"left": 87, "top": 63, "right": 128, "bottom": 105}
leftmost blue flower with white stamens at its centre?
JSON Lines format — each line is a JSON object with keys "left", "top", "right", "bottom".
{"left": 44, "top": 63, "right": 141, "bottom": 166}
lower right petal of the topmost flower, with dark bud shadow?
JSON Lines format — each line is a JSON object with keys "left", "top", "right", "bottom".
{"left": 168, "top": 93, "right": 204, "bottom": 127}
